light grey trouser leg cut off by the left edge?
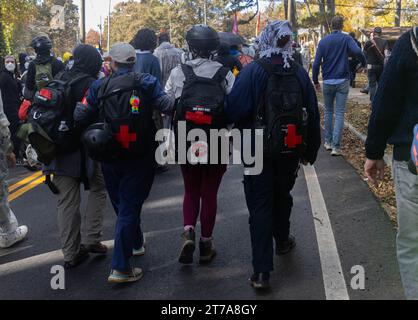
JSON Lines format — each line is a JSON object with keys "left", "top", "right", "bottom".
{"left": 0, "top": 148, "right": 18, "bottom": 235}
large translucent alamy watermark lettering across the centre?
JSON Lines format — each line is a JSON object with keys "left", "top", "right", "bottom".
{"left": 155, "top": 121, "right": 263, "bottom": 175}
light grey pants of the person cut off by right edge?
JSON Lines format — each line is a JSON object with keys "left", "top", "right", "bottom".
{"left": 393, "top": 161, "right": 418, "bottom": 300}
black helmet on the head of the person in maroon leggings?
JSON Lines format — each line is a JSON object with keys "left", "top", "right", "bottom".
{"left": 186, "top": 24, "right": 220, "bottom": 58}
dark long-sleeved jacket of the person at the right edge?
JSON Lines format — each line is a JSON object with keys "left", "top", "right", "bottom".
{"left": 366, "top": 28, "right": 418, "bottom": 161}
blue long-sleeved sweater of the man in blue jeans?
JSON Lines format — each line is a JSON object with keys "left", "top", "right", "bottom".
{"left": 312, "top": 31, "right": 366, "bottom": 84}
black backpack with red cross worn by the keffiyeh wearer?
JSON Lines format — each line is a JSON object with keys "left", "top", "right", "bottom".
{"left": 256, "top": 59, "right": 308, "bottom": 157}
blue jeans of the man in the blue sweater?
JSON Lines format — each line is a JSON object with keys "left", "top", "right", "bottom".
{"left": 323, "top": 80, "right": 350, "bottom": 149}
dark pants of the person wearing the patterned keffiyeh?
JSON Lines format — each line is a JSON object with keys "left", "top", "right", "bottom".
{"left": 244, "top": 155, "right": 300, "bottom": 273}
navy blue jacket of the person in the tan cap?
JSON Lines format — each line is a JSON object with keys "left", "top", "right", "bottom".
{"left": 74, "top": 68, "right": 174, "bottom": 126}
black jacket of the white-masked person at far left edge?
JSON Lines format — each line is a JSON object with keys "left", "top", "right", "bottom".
{"left": 0, "top": 69, "right": 22, "bottom": 123}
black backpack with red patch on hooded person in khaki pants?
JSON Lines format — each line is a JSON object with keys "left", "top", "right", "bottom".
{"left": 27, "top": 74, "right": 90, "bottom": 165}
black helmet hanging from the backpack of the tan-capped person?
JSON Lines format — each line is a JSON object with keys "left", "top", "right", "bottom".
{"left": 82, "top": 123, "right": 120, "bottom": 161}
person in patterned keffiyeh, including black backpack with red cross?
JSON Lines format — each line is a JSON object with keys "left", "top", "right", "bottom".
{"left": 226, "top": 21, "right": 321, "bottom": 289}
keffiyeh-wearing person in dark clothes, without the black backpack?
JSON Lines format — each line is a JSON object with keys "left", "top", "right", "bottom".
{"left": 225, "top": 21, "right": 321, "bottom": 289}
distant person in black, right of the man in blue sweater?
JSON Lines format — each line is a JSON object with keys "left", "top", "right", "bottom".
{"left": 364, "top": 27, "right": 389, "bottom": 101}
